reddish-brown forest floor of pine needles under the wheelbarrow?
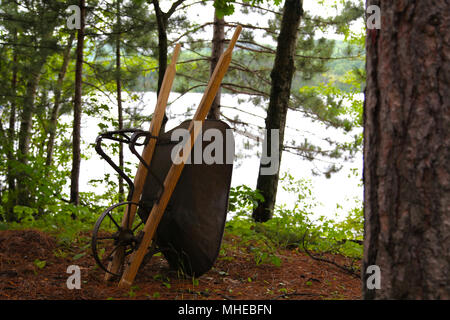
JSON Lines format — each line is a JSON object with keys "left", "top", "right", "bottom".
{"left": 0, "top": 229, "right": 361, "bottom": 300}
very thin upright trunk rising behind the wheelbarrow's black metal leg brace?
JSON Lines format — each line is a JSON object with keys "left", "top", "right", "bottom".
{"left": 116, "top": 0, "right": 125, "bottom": 202}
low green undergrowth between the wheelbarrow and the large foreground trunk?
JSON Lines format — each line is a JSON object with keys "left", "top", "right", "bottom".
{"left": 221, "top": 174, "right": 363, "bottom": 266}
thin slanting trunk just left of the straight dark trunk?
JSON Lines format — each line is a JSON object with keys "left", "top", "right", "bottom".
{"left": 45, "top": 33, "right": 75, "bottom": 166}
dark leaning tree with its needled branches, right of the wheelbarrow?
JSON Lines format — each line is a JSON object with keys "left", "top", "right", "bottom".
{"left": 219, "top": 2, "right": 362, "bottom": 221}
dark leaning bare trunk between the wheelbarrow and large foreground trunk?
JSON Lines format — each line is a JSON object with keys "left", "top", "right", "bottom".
{"left": 253, "top": 0, "right": 303, "bottom": 222}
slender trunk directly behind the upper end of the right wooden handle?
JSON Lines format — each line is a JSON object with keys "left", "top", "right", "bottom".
{"left": 208, "top": 10, "right": 225, "bottom": 120}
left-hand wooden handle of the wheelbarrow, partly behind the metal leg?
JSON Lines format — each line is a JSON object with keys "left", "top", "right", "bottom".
{"left": 105, "top": 44, "right": 181, "bottom": 280}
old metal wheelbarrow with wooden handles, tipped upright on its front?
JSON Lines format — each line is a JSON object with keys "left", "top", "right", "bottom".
{"left": 91, "top": 26, "right": 242, "bottom": 287}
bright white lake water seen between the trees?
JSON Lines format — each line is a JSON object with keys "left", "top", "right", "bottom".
{"left": 74, "top": 92, "right": 362, "bottom": 219}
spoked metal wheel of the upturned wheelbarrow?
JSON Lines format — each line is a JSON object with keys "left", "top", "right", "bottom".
{"left": 91, "top": 201, "right": 144, "bottom": 277}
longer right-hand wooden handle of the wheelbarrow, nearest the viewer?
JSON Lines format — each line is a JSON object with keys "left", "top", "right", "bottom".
{"left": 119, "top": 26, "right": 242, "bottom": 288}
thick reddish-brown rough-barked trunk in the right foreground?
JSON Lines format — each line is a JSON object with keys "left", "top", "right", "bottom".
{"left": 362, "top": 0, "right": 450, "bottom": 299}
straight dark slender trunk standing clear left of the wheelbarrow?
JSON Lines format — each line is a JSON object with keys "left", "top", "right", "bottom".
{"left": 70, "top": 0, "right": 86, "bottom": 205}
